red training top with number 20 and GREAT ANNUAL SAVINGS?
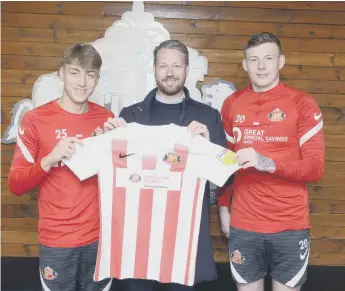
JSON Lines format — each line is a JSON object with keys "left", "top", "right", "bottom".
{"left": 219, "top": 83, "right": 324, "bottom": 233}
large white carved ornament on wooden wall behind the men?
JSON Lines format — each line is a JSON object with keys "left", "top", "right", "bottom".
{"left": 1, "top": 1, "right": 233, "bottom": 143}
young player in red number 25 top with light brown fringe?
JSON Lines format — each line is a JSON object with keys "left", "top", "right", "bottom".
{"left": 8, "top": 44, "right": 113, "bottom": 291}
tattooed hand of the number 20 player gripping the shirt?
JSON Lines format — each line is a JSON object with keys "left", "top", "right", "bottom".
{"left": 236, "top": 148, "right": 276, "bottom": 173}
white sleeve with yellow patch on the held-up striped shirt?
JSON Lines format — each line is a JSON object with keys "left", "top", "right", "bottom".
{"left": 188, "top": 135, "right": 240, "bottom": 187}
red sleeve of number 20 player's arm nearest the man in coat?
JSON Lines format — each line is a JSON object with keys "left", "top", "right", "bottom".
{"left": 218, "top": 96, "right": 235, "bottom": 207}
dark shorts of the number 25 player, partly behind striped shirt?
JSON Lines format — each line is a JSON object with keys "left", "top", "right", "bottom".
{"left": 39, "top": 242, "right": 111, "bottom": 291}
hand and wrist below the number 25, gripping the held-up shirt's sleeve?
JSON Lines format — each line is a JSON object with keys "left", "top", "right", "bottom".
{"left": 41, "top": 137, "right": 83, "bottom": 172}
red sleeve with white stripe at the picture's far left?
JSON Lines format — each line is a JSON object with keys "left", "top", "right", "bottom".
{"left": 8, "top": 112, "right": 48, "bottom": 195}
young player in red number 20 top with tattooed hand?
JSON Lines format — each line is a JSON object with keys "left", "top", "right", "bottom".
{"left": 219, "top": 33, "right": 324, "bottom": 291}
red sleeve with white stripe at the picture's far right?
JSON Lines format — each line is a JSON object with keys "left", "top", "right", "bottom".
{"left": 273, "top": 94, "right": 325, "bottom": 182}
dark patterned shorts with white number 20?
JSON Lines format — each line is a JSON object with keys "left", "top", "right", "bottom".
{"left": 229, "top": 227, "right": 310, "bottom": 288}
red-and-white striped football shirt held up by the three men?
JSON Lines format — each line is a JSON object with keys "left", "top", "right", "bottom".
{"left": 66, "top": 123, "right": 239, "bottom": 285}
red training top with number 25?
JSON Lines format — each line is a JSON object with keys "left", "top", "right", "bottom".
{"left": 8, "top": 100, "right": 114, "bottom": 247}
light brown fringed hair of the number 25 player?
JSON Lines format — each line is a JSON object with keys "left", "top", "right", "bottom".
{"left": 61, "top": 44, "right": 102, "bottom": 71}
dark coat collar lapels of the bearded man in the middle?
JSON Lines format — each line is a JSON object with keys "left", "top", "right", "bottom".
{"left": 134, "top": 87, "right": 191, "bottom": 123}
